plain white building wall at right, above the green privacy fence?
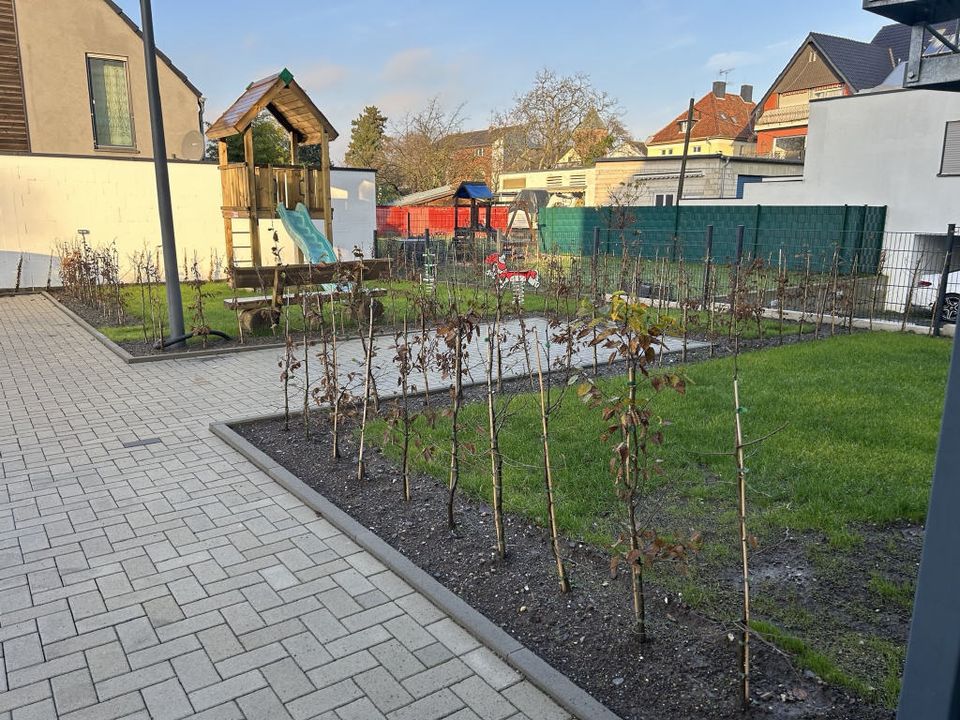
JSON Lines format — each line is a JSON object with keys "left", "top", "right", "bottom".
{"left": 742, "top": 90, "right": 960, "bottom": 233}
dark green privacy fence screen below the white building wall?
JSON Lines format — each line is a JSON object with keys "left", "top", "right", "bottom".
{"left": 538, "top": 205, "right": 887, "bottom": 273}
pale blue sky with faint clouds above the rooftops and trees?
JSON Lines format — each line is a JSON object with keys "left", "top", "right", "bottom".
{"left": 117, "top": 0, "right": 883, "bottom": 159}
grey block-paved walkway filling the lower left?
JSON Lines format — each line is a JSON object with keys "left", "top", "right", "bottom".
{"left": 0, "top": 296, "right": 704, "bottom": 720}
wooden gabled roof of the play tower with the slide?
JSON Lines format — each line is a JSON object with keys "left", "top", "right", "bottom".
{"left": 207, "top": 68, "right": 338, "bottom": 145}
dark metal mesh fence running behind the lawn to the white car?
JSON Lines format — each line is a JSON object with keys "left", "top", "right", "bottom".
{"left": 377, "top": 226, "right": 960, "bottom": 330}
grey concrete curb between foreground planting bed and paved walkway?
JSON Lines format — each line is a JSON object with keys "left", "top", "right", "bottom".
{"left": 210, "top": 415, "right": 620, "bottom": 720}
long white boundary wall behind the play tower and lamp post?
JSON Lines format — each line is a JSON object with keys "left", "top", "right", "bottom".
{"left": 0, "top": 155, "right": 376, "bottom": 288}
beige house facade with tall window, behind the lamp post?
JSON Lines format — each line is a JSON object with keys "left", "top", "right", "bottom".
{"left": 0, "top": 0, "right": 204, "bottom": 160}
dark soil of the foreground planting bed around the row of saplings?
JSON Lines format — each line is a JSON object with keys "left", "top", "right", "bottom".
{"left": 236, "top": 374, "right": 892, "bottom": 720}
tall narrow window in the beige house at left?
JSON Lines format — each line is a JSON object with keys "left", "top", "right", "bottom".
{"left": 87, "top": 55, "right": 137, "bottom": 149}
